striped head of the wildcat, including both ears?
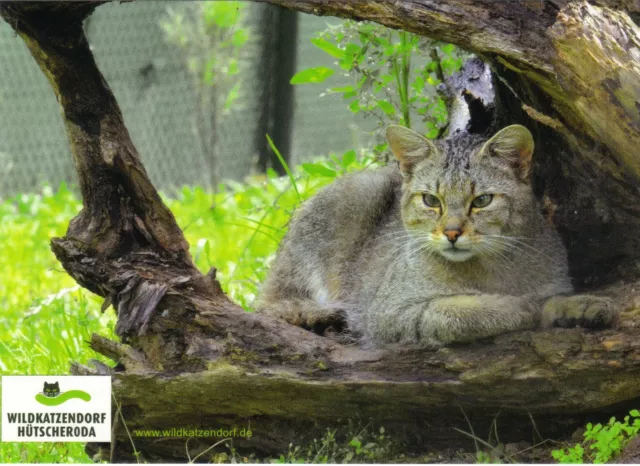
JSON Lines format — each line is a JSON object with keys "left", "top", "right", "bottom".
{"left": 387, "top": 126, "right": 535, "bottom": 262}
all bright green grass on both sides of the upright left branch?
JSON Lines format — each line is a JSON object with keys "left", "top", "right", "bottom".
{"left": 0, "top": 152, "right": 370, "bottom": 463}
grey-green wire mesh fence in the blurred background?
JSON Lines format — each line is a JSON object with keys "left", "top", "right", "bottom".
{"left": 0, "top": 1, "right": 378, "bottom": 197}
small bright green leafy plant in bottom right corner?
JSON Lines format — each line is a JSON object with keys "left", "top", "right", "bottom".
{"left": 551, "top": 409, "right": 640, "bottom": 464}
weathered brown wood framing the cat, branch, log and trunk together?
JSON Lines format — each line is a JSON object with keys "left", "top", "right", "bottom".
{"left": 0, "top": 0, "right": 640, "bottom": 461}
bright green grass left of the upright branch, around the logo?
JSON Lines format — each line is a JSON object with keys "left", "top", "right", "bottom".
{"left": 0, "top": 185, "right": 115, "bottom": 463}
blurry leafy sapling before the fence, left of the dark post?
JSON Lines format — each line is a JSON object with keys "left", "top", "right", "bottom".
{"left": 160, "top": 1, "right": 251, "bottom": 187}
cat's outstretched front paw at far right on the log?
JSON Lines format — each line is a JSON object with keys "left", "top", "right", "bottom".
{"left": 541, "top": 295, "right": 616, "bottom": 328}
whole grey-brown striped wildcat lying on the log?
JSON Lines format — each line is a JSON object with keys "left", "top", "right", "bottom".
{"left": 257, "top": 125, "right": 613, "bottom": 347}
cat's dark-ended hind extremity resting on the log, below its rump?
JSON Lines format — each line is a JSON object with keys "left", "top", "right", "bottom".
{"left": 256, "top": 298, "right": 346, "bottom": 334}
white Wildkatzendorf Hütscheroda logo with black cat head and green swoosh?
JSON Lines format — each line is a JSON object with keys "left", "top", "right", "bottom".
{"left": 2, "top": 375, "right": 111, "bottom": 442}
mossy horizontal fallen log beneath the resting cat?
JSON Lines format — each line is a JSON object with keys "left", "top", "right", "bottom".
{"left": 87, "top": 290, "right": 640, "bottom": 461}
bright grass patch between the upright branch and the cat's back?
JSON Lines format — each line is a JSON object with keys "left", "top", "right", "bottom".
{"left": 165, "top": 151, "right": 373, "bottom": 310}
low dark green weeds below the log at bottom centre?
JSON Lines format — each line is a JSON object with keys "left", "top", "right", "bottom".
{"left": 274, "top": 427, "right": 397, "bottom": 464}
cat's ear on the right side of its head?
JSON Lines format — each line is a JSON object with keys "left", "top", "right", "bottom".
{"left": 480, "top": 125, "right": 534, "bottom": 181}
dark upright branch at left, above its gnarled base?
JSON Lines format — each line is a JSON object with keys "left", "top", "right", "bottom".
{"left": 0, "top": 2, "right": 193, "bottom": 266}
